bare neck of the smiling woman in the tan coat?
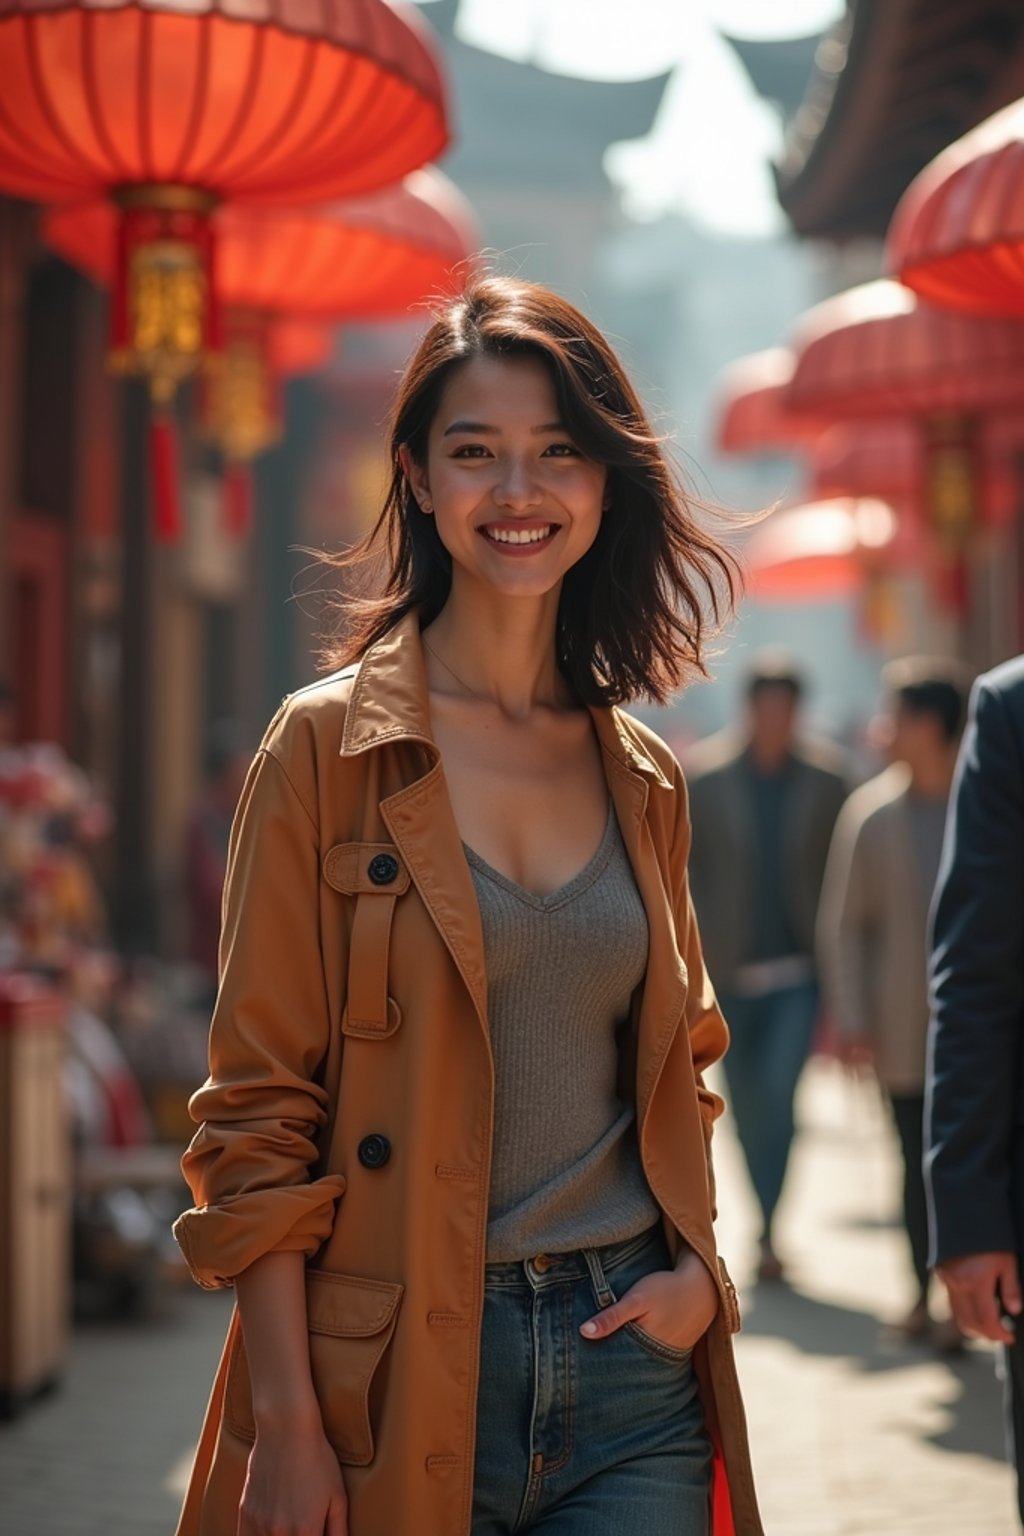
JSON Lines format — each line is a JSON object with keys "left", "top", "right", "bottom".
{"left": 424, "top": 587, "right": 571, "bottom": 719}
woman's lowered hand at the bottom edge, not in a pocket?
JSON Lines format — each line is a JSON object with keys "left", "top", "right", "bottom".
{"left": 238, "top": 1421, "right": 348, "bottom": 1536}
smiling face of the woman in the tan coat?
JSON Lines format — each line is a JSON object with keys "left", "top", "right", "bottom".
{"left": 402, "top": 358, "right": 606, "bottom": 598}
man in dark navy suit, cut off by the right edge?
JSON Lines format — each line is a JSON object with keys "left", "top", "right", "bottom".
{"left": 924, "top": 657, "right": 1024, "bottom": 1522}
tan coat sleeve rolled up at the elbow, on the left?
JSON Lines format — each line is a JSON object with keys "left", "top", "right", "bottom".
{"left": 173, "top": 745, "right": 345, "bottom": 1289}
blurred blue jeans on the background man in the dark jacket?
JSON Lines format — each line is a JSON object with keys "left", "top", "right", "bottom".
{"left": 718, "top": 982, "right": 818, "bottom": 1238}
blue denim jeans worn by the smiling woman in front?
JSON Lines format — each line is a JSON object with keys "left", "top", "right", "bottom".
{"left": 473, "top": 1227, "right": 711, "bottom": 1536}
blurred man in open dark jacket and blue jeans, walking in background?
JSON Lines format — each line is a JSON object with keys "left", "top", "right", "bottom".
{"left": 688, "top": 653, "right": 847, "bottom": 1279}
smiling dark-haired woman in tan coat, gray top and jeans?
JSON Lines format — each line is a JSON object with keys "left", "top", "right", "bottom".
{"left": 177, "top": 278, "right": 761, "bottom": 1536}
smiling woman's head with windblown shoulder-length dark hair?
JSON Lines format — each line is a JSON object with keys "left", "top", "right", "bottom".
{"left": 333, "top": 276, "right": 737, "bottom": 703}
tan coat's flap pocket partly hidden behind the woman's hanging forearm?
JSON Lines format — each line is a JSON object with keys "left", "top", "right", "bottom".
{"left": 224, "top": 1270, "right": 404, "bottom": 1467}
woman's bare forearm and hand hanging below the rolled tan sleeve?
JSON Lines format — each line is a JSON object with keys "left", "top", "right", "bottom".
{"left": 235, "top": 1252, "right": 348, "bottom": 1536}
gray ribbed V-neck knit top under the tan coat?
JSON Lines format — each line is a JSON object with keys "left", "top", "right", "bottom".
{"left": 465, "top": 808, "right": 659, "bottom": 1263}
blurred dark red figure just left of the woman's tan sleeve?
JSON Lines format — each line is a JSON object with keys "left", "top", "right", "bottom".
{"left": 184, "top": 720, "right": 252, "bottom": 1005}
